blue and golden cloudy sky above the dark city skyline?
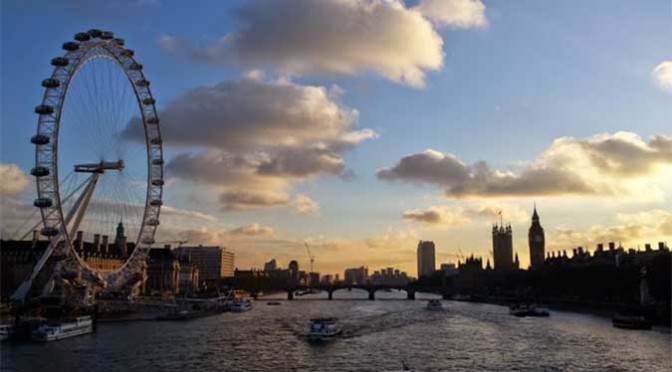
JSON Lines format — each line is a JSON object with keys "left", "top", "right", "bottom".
{"left": 0, "top": 0, "right": 672, "bottom": 275}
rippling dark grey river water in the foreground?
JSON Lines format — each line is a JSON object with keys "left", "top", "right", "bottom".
{"left": 0, "top": 290, "right": 672, "bottom": 372}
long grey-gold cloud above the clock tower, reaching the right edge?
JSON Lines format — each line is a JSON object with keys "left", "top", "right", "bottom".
{"left": 376, "top": 132, "right": 672, "bottom": 198}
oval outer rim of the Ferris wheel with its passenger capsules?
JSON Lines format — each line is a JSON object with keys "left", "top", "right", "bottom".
{"left": 31, "top": 30, "right": 164, "bottom": 288}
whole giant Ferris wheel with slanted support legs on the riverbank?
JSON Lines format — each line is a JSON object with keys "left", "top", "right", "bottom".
{"left": 12, "top": 29, "right": 164, "bottom": 300}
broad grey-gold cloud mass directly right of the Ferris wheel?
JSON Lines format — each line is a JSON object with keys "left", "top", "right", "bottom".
{"left": 122, "top": 73, "right": 377, "bottom": 214}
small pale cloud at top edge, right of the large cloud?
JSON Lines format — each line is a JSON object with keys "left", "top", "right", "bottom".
{"left": 415, "top": 0, "right": 488, "bottom": 29}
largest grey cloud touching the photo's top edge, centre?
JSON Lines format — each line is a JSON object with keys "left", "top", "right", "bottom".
{"left": 159, "top": 0, "right": 448, "bottom": 88}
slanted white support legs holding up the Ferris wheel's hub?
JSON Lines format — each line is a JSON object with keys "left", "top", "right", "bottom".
{"left": 11, "top": 173, "right": 100, "bottom": 301}
